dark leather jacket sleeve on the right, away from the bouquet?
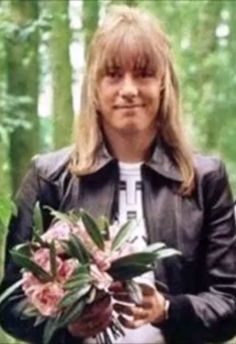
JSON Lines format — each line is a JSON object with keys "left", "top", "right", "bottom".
{"left": 159, "top": 163, "right": 236, "bottom": 344}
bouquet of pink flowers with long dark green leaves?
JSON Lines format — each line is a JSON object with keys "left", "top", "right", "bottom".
{"left": 0, "top": 209, "right": 178, "bottom": 344}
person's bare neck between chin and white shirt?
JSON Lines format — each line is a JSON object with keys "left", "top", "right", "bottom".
{"left": 103, "top": 127, "right": 156, "bottom": 163}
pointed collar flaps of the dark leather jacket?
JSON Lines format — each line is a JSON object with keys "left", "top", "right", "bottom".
{"left": 94, "top": 142, "right": 183, "bottom": 182}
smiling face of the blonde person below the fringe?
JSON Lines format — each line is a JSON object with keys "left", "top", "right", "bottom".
{"left": 98, "top": 62, "right": 161, "bottom": 136}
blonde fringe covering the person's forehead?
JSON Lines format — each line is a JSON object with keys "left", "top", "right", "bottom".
{"left": 93, "top": 23, "right": 166, "bottom": 80}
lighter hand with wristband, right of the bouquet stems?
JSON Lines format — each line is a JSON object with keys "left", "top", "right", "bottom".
{"left": 111, "top": 282, "right": 165, "bottom": 329}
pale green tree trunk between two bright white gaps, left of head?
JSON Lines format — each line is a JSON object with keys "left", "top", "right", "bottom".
{"left": 48, "top": 0, "right": 73, "bottom": 148}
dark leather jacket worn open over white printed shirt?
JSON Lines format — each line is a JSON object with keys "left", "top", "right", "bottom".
{"left": 0, "top": 146, "right": 236, "bottom": 344}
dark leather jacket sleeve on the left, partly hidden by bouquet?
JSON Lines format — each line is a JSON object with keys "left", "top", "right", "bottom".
{"left": 0, "top": 159, "right": 81, "bottom": 344}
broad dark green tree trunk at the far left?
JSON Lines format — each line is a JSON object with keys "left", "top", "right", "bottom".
{"left": 6, "top": 0, "right": 39, "bottom": 192}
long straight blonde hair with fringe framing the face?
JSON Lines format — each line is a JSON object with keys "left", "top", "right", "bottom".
{"left": 71, "top": 6, "right": 194, "bottom": 194}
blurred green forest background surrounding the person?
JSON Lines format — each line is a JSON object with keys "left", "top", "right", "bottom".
{"left": 0, "top": 0, "right": 236, "bottom": 344}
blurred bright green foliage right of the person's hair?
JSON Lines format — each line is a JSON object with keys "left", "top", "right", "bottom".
{"left": 139, "top": 0, "right": 236, "bottom": 192}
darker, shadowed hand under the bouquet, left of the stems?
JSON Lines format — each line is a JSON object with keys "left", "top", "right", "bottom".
{"left": 68, "top": 295, "right": 112, "bottom": 337}
